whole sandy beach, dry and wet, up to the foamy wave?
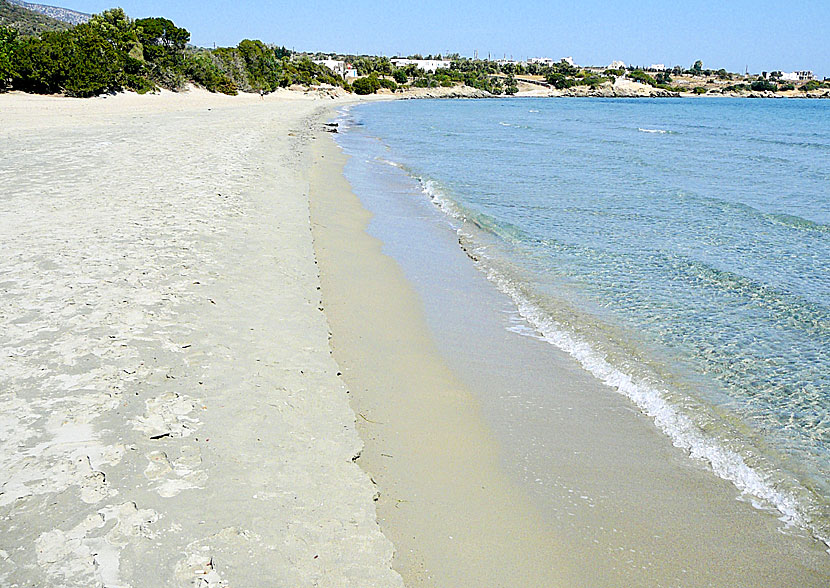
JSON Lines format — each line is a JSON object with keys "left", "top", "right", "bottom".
{"left": 0, "top": 90, "right": 827, "bottom": 588}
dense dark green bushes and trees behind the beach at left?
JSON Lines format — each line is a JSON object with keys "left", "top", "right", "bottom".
{"left": 0, "top": 8, "right": 344, "bottom": 97}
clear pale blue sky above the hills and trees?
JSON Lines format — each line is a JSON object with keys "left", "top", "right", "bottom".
{"left": 66, "top": 0, "right": 830, "bottom": 76}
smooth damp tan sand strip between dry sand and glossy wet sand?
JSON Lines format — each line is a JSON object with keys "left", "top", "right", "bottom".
{"left": 311, "top": 112, "right": 575, "bottom": 586}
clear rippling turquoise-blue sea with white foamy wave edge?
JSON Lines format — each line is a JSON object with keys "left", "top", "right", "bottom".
{"left": 339, "top": 99, "right": 830, "bottom": 542}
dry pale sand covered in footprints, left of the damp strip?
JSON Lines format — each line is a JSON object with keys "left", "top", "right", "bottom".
{"left": 0, "top": 91, "right": 402, "bottom": 587}
